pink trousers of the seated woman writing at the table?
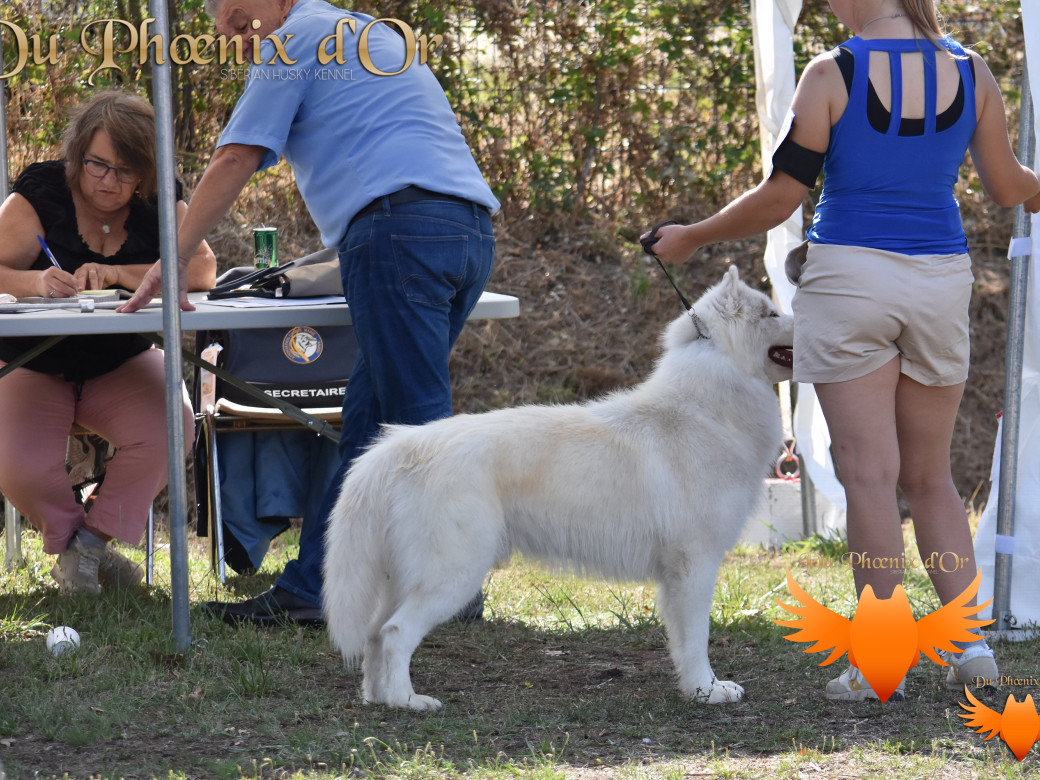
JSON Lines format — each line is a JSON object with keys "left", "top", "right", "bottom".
{"left": 0, "top": 348, "right": 192, "bottom": 554}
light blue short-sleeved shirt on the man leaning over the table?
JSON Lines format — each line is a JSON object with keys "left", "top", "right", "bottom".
{"left": 217, "top": 0, "right": 499, "bottom": 246}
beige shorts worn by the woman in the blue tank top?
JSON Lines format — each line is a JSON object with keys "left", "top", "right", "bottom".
{"left": 792, "top": 243, "right": 974, "bottom": 387}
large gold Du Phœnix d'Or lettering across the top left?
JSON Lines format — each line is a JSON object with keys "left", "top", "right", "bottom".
{"left": 0, "top": 17, "right": 443, "bottom": 84}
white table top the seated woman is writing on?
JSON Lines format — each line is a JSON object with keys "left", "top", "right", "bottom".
{"left": 0, "top": 291, "right": 520, "bottom": 336}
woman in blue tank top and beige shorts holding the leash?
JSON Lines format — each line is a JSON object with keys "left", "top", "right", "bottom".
{"left": 653, "top": 0, "right": 1040, "bottom": 701}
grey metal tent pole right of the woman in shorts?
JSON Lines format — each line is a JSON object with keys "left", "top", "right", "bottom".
{"left": 990, "top": 60, "right": 1036, "bottom": 631}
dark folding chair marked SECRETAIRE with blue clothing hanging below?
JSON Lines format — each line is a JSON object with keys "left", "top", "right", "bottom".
{"left": 192, "top": 301, "right": 358, "bottom": 582}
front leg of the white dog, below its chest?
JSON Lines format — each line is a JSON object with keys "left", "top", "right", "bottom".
{"left": 657, "top": 553, "right": 744, "bottom": 704}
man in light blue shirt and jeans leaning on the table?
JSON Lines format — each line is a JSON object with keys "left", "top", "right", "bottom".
{"left": 122, "top": 0, "right": 499, "bottom": 623}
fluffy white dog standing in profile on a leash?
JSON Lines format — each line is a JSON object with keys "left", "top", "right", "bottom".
{"left": 323, "top": 267, "right": 792, "bottom": 709}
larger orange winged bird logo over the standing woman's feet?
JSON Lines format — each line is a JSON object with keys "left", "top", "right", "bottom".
{"left": 773, "top": 571, "right": 993, "bottom": 702}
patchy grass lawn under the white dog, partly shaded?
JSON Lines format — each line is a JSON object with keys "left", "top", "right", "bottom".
{"left": 0, "top": 515, "right": 1040, "bottom": 780}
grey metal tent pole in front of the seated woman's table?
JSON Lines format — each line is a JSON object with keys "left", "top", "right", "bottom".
{"left": 149, "top": 0, "right": 191, "bottom": 651}
